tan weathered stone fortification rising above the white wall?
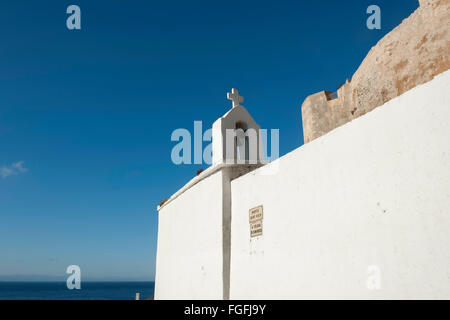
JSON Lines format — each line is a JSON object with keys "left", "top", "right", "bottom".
{"left": 302, "top": 0, "right": 450, "bottom": 143}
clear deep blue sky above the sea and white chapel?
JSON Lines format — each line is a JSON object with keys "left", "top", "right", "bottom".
{"left": 0, "top": 0, "right": 418, "bottom": 280}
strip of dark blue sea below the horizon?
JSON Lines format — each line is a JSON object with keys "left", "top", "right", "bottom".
{"left": 0, "top": 281, "right": 155, "bottom": 300}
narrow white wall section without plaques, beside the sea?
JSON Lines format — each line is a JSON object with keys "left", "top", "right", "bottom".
{"left": 155, "top": 171, "right": 223, "bottom": 299}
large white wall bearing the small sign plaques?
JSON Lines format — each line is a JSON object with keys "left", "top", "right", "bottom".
{"left": 230, "top": 71, "right": 450, "bottom": 299}
